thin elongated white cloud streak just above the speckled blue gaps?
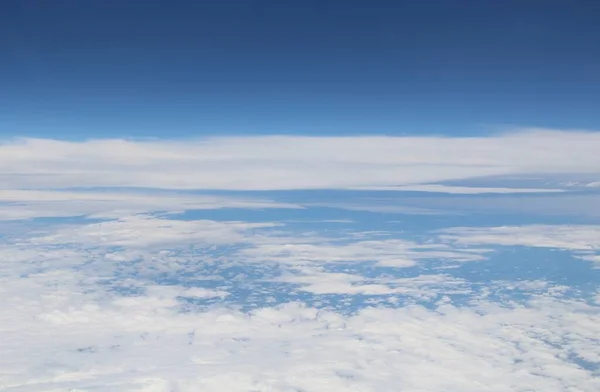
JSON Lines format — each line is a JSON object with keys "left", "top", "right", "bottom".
{"left": 14, "top": 214, "right": 488, "bottom": 268}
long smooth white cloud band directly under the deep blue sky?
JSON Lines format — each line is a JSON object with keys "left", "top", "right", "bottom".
{"left": 0, "top": 129, "right": 600, "bottom": 190}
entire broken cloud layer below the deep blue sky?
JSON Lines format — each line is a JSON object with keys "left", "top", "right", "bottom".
{"left": 0, "top": 130, "right": 600, "bottom": 392}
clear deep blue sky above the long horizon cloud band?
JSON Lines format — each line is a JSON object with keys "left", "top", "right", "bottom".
{"left": 0, "top": 0, "right": 600, "bottom": 138}
